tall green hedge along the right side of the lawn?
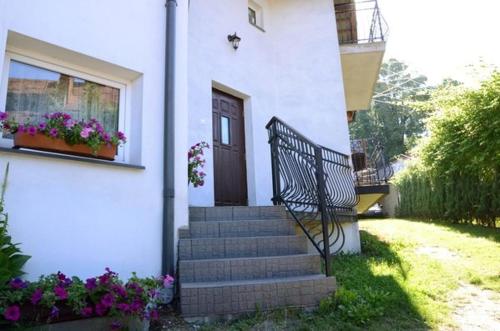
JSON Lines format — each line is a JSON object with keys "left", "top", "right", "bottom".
{"left": 395, "top": 73, "right": 500, "bottom": 226}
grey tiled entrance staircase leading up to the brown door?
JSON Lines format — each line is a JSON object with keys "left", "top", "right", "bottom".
{"left": 179, "top": 206, "right": 336, "bottom": 318}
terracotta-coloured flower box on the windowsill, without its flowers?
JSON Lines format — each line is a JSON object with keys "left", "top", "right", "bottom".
{"left": 14, "top": 132, "right": 116, "bottom": 161}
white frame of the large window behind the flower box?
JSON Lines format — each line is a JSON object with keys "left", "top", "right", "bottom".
{"left": 0, "top": 50, "right": 131, "bottom": 162}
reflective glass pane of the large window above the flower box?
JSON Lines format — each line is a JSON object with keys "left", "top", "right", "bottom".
{"left": 5, "top": 60, "right": 120, "bottom": 132}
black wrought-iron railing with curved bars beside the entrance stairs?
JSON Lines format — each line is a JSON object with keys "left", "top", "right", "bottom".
{"left": 266, "top": 117, "right": 357, "bottom": 275}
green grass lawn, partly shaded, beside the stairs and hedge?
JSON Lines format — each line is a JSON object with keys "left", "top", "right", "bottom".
{"left": 196, "top": 219, "right": 500, "bottom": 330}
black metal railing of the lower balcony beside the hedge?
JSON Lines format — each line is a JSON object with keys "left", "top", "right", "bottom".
{"left": 351, "top": 139, "right": 394, "bottom": 186}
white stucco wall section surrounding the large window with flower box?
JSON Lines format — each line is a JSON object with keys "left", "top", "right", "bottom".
{"left": 0, "top": 0, "right": 187, "bottom": 279}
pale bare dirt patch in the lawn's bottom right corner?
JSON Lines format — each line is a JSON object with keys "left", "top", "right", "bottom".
{"left": 450, "top": 284, "right": 500, "bottom": 331}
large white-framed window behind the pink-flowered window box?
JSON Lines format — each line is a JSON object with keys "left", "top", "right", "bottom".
{"left": 0, "top": 53, "right": 127, "bottom": 161}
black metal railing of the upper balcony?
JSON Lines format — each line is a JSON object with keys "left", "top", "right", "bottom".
{"left": 335, "top": 0, "right": 388, "bottom": 45}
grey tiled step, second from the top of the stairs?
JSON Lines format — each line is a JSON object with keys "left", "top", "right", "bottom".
{"left": 179, "top": 219, "right": 296, "bottom": 239}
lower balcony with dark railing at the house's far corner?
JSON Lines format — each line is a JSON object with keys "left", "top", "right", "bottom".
{"left": 351, "top": 139, "right": 394, "bottom": 214}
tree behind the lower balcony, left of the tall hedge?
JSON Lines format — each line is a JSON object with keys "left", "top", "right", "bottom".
{"left": 350, "top": 59, "right": 429, "bottom": 159}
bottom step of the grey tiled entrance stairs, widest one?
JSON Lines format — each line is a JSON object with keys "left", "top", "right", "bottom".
{"left": 181, "top": 275, "right": 336, "bottom": 318}
